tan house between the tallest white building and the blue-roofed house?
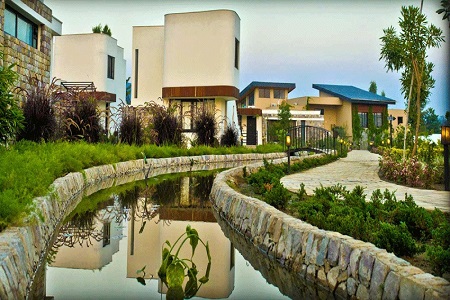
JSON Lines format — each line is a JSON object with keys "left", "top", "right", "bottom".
{"left": 237, "top": 81, "right": 323, "bottom": 145}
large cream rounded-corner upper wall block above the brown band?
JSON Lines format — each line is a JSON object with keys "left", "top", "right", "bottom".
{"left": 163, "top": 10, "right": 240, "bottom": 87}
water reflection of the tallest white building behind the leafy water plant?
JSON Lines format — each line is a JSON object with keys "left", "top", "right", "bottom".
{"left": 127, "top": 177, "right": 235, "bottom": 298}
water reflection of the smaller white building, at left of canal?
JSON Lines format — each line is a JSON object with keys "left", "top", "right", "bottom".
{"left": 51, "top": 202, "right": 123, "bottom": 270}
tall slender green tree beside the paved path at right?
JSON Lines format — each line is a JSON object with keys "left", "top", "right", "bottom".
{"left": 380, "top": 6, "right": 444, "bottom": 158}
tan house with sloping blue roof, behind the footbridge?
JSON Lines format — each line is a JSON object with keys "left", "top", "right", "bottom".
{"left": 289, "top": 84, "right": 395, "bottom": 138}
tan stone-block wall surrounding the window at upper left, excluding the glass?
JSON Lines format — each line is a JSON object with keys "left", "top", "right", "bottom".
{"left": 0, "top": 0, "right": 53, "bottom": 89}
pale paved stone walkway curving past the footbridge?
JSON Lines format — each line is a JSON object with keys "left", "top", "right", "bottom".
{"left": 281, "top": 150, "right": 450, "bottom": 212}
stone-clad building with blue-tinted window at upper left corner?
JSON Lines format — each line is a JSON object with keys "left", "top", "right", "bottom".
{"left": 0, "top": 0, "right": 62, "bottom": 89}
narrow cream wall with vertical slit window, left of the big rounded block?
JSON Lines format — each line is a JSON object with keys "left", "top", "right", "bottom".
{"left": 131, "top": 26, "right": 164, "bottom": 106}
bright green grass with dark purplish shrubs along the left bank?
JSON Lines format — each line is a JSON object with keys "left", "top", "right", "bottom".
{"left": 0, "top": 53, "right": 283, "bottom": 231}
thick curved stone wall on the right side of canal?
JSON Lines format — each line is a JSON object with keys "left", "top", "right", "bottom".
{"left": 210, "top": 158, "right": 450, "bottom": 300}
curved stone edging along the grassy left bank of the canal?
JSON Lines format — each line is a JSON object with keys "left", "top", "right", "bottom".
{"left": 0, "top": 152, "right": 286, "bottom": 299}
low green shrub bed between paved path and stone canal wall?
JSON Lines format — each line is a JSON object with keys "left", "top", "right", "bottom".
{"left": 233, "top": 156, "right": 450, "bottom": 277}
